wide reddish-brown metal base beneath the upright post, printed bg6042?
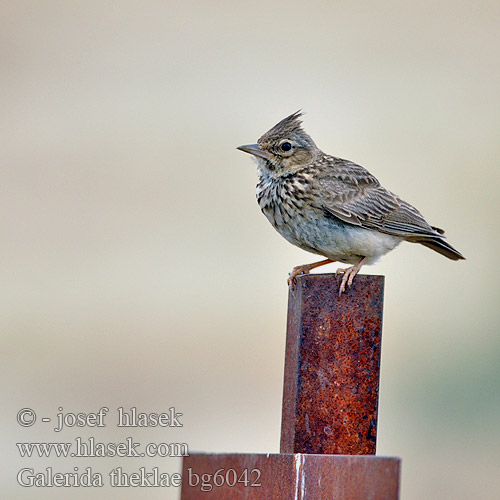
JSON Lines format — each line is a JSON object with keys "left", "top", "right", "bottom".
{"left": 181, "top": 453, "right": 400, "bottom": 500}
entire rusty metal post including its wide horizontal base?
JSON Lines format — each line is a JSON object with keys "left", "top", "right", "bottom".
{"left": 181, "top": 274, "right": 400, "bottom": 500}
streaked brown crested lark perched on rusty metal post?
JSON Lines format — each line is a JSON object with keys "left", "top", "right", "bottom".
{"left": 237, "top": 111, "right": 465, "bottom": 295}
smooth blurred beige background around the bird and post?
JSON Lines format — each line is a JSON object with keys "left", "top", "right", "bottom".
{"left": 0, "top": 0, "right": 500, "bottom": 500}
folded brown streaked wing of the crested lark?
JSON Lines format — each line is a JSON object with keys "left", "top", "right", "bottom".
{"left": 319, "top": 157, "right": 443, "bottom": 240}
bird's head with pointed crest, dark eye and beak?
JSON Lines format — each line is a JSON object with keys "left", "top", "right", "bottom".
{"left": 237, "top": 111, "right": 320, "bottom": 175}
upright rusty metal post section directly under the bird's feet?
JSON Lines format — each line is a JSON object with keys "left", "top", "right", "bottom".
{"left": 280, "top": 274, "right": 384, "bottom": 456}
